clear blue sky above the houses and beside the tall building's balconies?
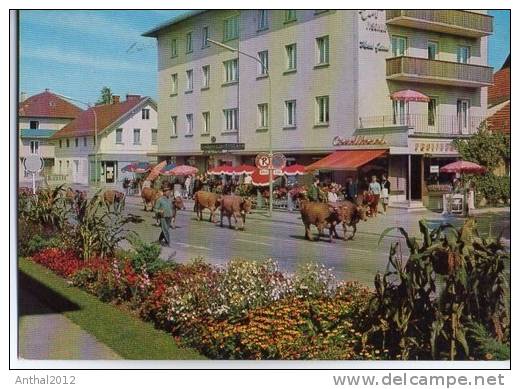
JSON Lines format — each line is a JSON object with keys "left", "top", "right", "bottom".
{"left": 19, "top": 10, "right": 510, "bottom": 102}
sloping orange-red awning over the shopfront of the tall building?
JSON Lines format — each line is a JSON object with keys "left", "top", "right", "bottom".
{"left": 306, "top": 149, "right": 388, "bottom": 171}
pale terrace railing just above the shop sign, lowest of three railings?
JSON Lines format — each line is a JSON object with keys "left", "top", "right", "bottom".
{"left": 359, "top": 114, "right": 486, "bottom": 136}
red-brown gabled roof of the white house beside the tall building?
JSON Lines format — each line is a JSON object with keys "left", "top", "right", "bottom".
{"left": 52, "top": 96, "right": 155, "bottom": 139}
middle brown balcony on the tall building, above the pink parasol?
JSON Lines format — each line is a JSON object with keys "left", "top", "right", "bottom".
{"left": 386, "top": 56, "right": 493, "bottom": 88}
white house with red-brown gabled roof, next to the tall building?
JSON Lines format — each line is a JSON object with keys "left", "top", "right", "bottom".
{"left": 52, "top": 95, "right": 157, "bottom": 185}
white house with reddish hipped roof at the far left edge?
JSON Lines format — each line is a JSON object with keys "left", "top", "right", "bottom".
{"left": 18, "top": 89, "right": 82, "bottom": 181}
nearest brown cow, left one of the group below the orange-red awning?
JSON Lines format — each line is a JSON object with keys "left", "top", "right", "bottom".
{"left": 300, "top": 200, "right": 345, "bottom": 242}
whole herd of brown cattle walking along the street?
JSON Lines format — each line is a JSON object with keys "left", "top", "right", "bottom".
{"left": 66, "top": 188, "right": 369, "bottom": 242}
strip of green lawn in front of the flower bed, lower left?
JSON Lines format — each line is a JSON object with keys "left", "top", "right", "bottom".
{"left": 18, "top": 258, "right": 205, "bottom": 360}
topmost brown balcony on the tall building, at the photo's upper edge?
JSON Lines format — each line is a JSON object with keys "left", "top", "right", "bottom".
{"left": 386, "top": 9, "right": 493, "bottom": 38}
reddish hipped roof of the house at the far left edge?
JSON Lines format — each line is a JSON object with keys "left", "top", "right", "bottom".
{"left": 18, "top": 89, "right": 83, "bottom": 119}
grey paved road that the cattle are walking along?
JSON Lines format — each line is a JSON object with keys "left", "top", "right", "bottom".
{"left": 120, "top": 198, "right": 510, "bottom": 285}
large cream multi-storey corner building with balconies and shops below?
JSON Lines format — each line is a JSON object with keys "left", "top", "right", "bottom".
{"left": 144, "top": 10, "right": 493, "bottom": 205}
